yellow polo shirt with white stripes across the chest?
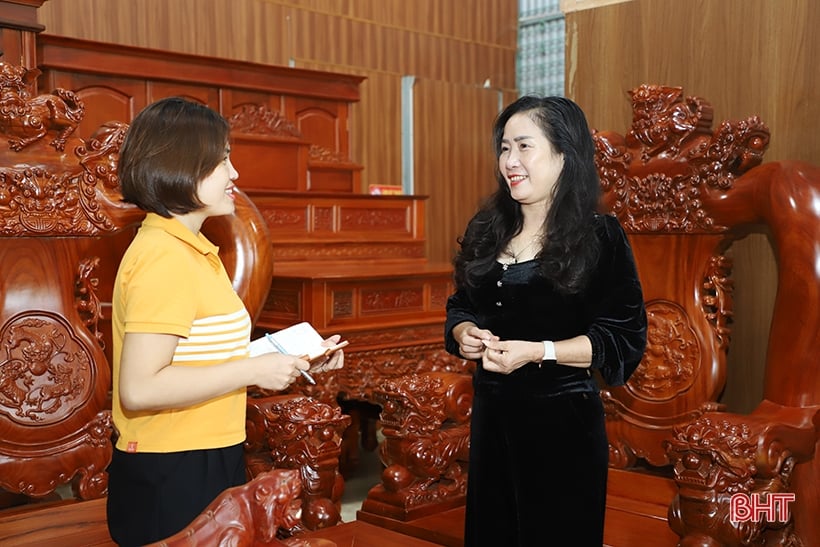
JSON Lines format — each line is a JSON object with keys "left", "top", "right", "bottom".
{"left": 112, "top": 213, "right": 251, "bottom": 452}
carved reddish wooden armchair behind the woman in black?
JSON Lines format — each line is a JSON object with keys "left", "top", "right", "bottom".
{"left": 594, "top": 85, "right": 820, "bottom": 546}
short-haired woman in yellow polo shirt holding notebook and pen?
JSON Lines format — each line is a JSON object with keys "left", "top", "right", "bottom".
{"left": 108, "top": 97, "right": 344, "bottom": 545}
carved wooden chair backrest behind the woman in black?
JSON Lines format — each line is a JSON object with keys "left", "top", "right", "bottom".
{"left": 594, "top": 85, "right": 820, "bottom": 467}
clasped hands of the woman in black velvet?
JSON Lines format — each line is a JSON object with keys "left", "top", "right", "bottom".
{"left": 453, "top": 323, "right": 544, "bottom": 374}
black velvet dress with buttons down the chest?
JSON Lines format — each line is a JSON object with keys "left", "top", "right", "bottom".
{"left": 445, "top": 215, "right": 646, "bottom": 547}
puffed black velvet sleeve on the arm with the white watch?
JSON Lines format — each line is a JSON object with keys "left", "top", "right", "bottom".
{"left": 587, "top": 215, "right": 647, "bottom": 387}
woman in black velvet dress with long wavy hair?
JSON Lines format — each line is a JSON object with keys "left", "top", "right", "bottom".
{"left": 445, "top": 96, "right": 646, "bottom": 547}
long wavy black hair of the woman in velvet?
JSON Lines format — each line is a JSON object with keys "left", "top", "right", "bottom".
{"left": 453, "top": 95, "right": 601, "bottom": 294}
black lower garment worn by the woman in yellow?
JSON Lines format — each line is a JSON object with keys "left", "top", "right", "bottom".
{"left": 107, "top": 444, "right": 246, "bottom": 546}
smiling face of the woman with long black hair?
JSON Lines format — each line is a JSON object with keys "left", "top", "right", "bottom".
{"left": 498, "top": 112, "right": 564, "bottom": 206}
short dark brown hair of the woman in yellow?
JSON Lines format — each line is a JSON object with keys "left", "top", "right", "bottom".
{"left": 117, "top": 97, "right": 230, "bottom": 218}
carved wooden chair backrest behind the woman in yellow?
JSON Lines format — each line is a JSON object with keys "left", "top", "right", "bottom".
{"left": 0, "top": 63, "right": 130, "bottom": 510}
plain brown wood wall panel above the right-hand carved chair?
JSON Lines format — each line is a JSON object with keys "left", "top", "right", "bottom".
{"left": 567, "top": 0, "right": 820, "bottom": 161}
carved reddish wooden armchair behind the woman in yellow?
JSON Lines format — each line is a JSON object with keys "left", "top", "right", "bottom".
{"left": 0, "top": 62, "right": 349, "bottom": 543}
